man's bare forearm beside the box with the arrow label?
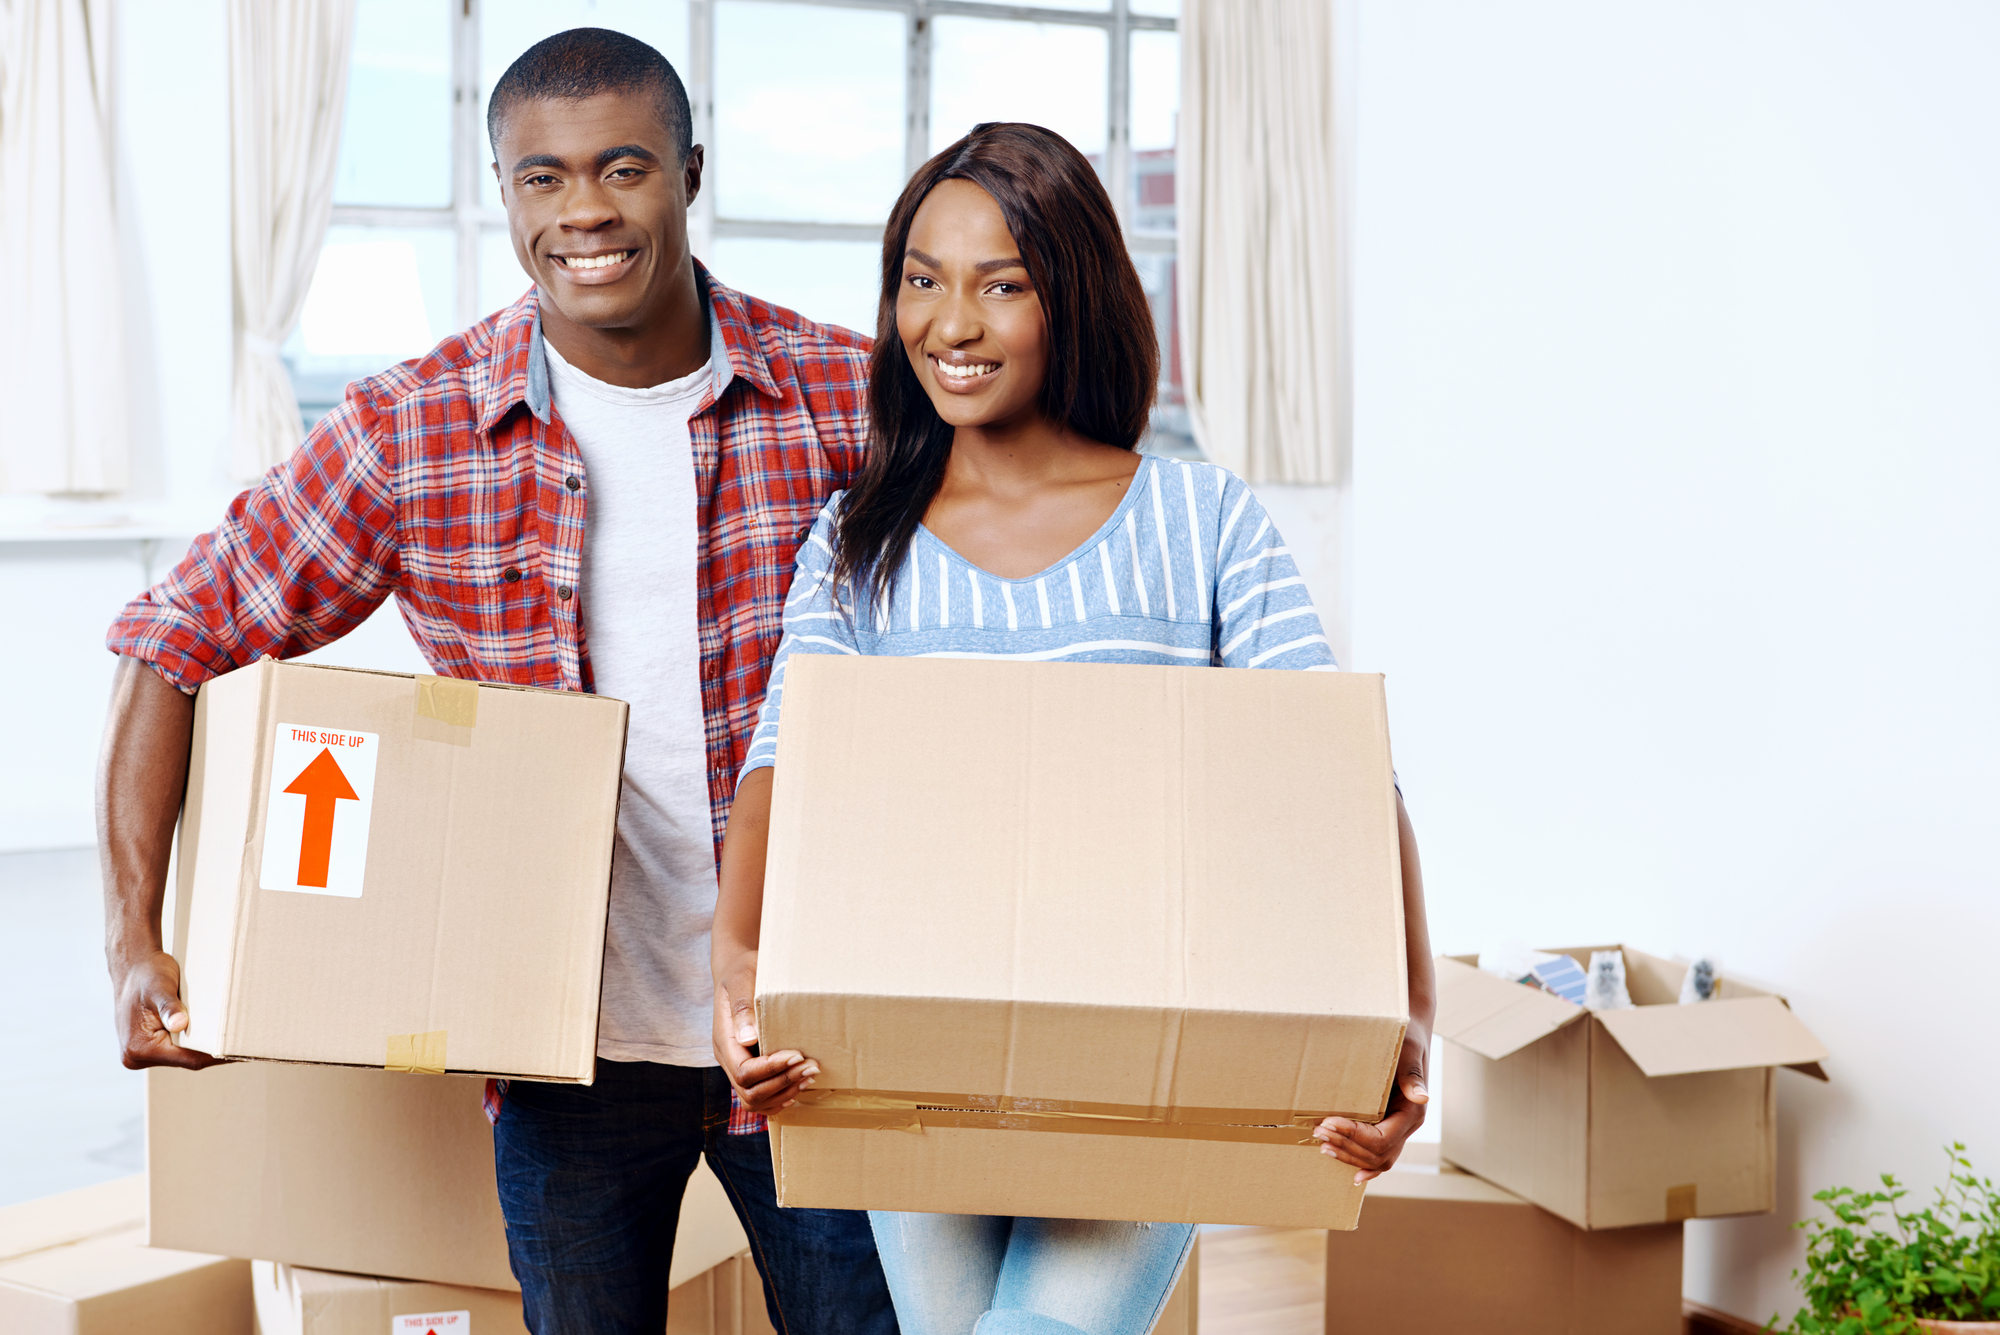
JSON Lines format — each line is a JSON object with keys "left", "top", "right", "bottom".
{"left": 98, "top": 658, "right": 194, "bottom": 977}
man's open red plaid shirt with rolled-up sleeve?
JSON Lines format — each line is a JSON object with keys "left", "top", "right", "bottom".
{"left": 106, "top": 270, "right": 870, "bottom": 1131}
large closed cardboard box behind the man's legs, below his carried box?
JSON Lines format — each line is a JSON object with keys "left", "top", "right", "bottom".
{"left": 146, "top": 1061, "right": 748, "bottom": 1289}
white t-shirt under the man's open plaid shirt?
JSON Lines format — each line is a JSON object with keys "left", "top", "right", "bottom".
{"left": 542, "top": 340, "right": 716, "bottom": 1065}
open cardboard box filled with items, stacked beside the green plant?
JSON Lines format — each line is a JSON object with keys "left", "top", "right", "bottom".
{"left": 1438, "top": 945, "right": 1826, "bottom": 1229}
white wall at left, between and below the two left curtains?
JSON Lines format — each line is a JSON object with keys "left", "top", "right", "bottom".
{"left": 0, "top": 0, "right": 420, "bottom": 851}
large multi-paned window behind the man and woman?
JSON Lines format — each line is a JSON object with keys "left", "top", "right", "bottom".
{"left": 286, "top": 0, "right": 1194, "bottom": 454}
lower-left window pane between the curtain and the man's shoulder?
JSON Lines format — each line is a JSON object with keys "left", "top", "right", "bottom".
{"left": 284, "top": 226, "right": 458, "bottom": 422}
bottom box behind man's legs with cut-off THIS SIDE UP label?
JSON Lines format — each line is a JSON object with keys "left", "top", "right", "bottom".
{"left": 254, "top": 1251, "right": 774, "bottom": 1335}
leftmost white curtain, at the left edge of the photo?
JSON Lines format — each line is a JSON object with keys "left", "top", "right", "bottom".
{"left": 0, "top": 0, "right": 130, "bottom": 494}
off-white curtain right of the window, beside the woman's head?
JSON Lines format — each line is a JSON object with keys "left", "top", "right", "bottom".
{"left": 1176, "top": 0, "right": 1352, "bottom": 486}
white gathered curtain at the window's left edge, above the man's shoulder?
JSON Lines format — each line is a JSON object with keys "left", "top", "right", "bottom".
{"left": 230, "top": 0, "right": 354, "bottom": 478}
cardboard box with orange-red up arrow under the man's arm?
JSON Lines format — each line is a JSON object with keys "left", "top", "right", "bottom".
{"left": 168, "top": 660, "right": 626, "bottom": 1081}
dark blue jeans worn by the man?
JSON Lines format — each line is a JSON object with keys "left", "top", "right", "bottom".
{"left": 494, "top": 1059, "right": 896, "bottom": 1335}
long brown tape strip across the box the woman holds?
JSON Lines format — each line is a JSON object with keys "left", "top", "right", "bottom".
{"left": 776, "top": 1089, "right": 1376, "bottom": 1145}
